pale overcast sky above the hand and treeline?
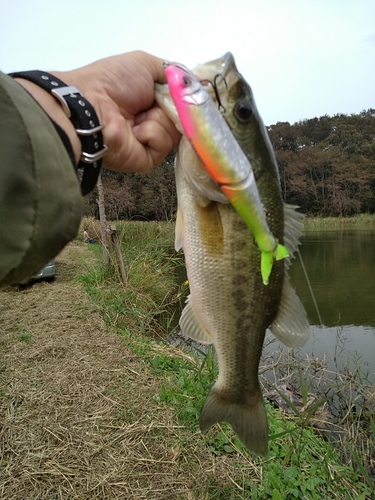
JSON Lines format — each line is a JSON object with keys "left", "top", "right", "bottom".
{"left": 0, "top": 0, "right": 375, "bottom": 125}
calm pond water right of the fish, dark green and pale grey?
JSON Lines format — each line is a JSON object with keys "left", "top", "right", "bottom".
{"left": 272, "top": 228, "right": 375, "bottom": 382}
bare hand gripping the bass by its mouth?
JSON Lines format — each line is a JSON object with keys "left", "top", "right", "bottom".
{"left": 52, "top": 51, "right": 181, "bottom": 173}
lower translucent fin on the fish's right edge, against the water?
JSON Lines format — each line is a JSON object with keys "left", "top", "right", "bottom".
{"left": 270, "top": 278, "right": 310, "bottom": 347}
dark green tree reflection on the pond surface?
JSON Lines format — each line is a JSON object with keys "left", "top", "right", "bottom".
{"left": 289, "top": 230, "right": 375, "bottom": 327}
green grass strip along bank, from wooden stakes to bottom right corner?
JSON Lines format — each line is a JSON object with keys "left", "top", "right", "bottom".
{"left": 78, "top": 222, "right": 375, "bottom": 500}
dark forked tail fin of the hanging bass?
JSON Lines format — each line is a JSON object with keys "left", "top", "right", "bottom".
{"left": 199, "top": 387, "right": 268, "bottom": 456}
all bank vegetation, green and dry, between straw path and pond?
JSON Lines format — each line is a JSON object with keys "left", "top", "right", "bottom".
{"left": 80, "top": 222, "right": 375, "bottom": 500}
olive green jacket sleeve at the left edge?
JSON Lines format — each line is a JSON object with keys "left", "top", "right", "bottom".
{"left": 0, "top": 72, "right": 82, "bottom": 285}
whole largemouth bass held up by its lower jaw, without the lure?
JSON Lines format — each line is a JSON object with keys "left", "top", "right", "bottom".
{"left": 155, "top": 53, "right": 309, "bottom": 456}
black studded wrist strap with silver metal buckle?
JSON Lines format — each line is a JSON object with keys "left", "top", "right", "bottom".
{"left": 10, "top": 70, "right": 107, "bottom": 195}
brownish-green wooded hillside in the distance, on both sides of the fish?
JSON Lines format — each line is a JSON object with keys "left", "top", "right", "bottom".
{"left": 85, "top": 109, "right": 375, "bottom": 220}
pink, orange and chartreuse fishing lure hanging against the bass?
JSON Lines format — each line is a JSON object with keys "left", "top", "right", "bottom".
{"left": 165, "top": 64, "right": 288, "bottom": 285}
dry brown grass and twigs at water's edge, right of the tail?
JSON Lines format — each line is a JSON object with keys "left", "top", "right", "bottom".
{"left": 260, "top": 342, "right": 375, "bottom": 480}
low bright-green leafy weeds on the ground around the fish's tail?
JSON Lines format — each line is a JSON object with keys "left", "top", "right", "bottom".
{"left": 149, "top": 344, "right": 372, "bottom": 500}
